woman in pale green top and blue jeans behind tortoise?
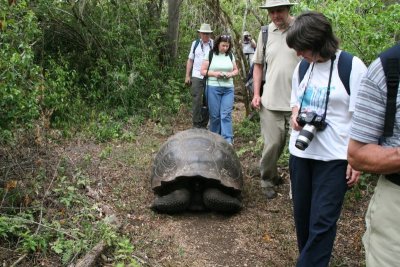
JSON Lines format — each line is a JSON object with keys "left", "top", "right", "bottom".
{"left": 201, "top": 34, "right": 239, "bottom": 145}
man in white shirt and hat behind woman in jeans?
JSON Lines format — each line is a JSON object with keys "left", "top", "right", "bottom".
{"left": 185, "top": 23, "right": 214, "bottom": 128}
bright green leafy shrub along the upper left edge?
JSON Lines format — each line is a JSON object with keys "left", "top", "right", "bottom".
{"left": 0, "top": 1, "right": 43, "bottom": 136}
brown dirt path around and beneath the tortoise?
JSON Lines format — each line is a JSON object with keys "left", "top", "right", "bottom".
{"left": 61, "top": 103, "right": 368, "bottom": 267}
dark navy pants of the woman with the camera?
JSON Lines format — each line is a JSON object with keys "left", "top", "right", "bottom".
{"left": 289, "top": 155, "right": 347, "bottom": 267}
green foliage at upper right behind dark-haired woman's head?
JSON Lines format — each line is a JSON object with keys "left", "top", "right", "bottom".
{"left": 299, "top": 0, "right": 400, "bottom": 65}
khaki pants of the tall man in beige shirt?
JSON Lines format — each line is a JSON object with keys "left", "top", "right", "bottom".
{"left": 260, "top": 105, "right": 291, "bottom": 187}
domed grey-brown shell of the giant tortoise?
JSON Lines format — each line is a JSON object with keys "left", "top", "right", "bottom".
{"left": 151, "top": 128, "right": 243, "bottom": 193}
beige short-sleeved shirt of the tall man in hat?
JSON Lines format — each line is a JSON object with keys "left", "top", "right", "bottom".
{"left": 253, "top": 22, "right": 300, "bottom": 111}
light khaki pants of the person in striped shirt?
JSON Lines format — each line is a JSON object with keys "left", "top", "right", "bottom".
{"left": 363, "top": 176, "right": 400, "bottom": 267}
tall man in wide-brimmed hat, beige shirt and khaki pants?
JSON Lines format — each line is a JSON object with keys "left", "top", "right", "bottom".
{"left": 252, "top": 0, "right": 300, "bottom": 199}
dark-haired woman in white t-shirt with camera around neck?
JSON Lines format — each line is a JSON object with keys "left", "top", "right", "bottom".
{"left": 286, "top": 11, "right": 367, "bottom": 267}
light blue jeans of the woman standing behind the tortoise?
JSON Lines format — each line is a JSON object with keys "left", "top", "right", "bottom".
{"left": 207, "top": 85, "right": 234, "bottom": 144}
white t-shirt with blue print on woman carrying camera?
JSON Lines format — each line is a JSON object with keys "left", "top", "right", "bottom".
{"left": 289, "top": 51, "right": 367, "bottom": 161}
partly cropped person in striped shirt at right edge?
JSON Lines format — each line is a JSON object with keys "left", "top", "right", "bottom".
{"left": 348, "top": 43, "right": 400, "bottom": 267}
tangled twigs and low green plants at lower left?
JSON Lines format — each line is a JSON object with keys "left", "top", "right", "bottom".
{"left": 0, "top": 135, "right": 143, "bottom": 266}
